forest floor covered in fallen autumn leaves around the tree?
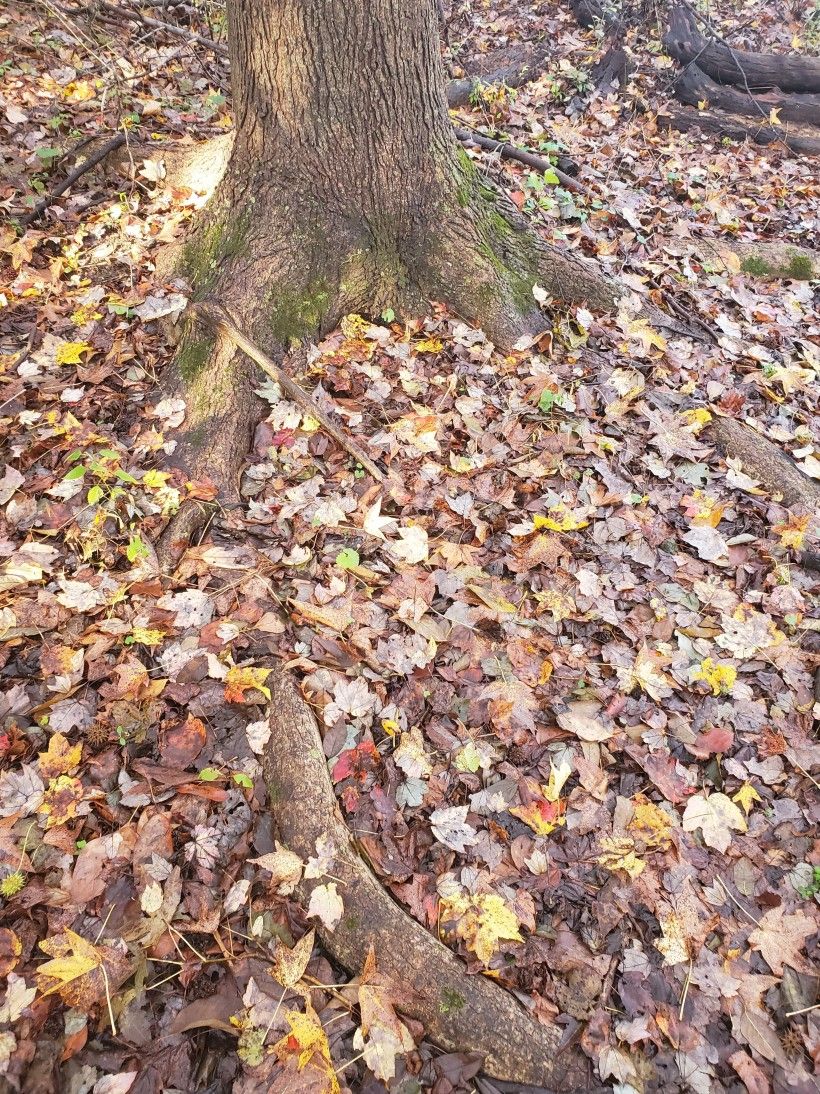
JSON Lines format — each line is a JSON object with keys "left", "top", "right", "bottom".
{"left": 0, "top": 0, "right": 820, "bottom": 1094}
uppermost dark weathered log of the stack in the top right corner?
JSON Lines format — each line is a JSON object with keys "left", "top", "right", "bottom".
{"left": 664, "top": 4, "right": 820, "bottom": 93}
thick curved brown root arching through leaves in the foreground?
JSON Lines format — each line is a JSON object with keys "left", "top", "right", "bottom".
{"left": 262, "top": 668, "right": 590, "bottom": 1091}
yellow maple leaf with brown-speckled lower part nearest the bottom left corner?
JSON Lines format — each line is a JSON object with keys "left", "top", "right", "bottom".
{"left": 34, "top": 928, "right": 130, "bottom": 1013}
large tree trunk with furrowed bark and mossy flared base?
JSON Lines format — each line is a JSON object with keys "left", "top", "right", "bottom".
{"left": 165, "top": 0, "right": 619, "bottom": 516}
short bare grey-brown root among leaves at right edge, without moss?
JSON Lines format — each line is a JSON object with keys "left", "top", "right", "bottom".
{"left": 710, "top": 418, "right": 820, "bottom": 509}
